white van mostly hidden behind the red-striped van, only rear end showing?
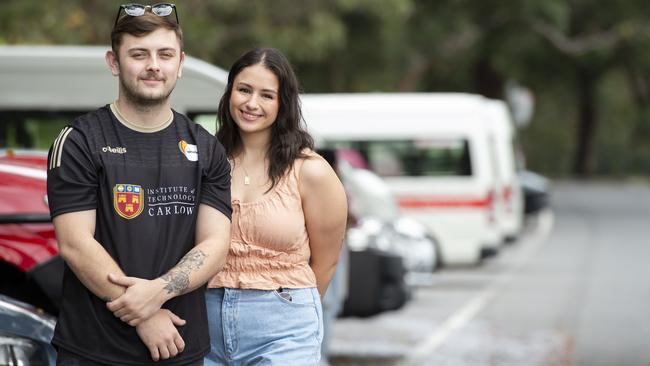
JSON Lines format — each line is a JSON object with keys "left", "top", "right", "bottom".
{"left": 487, "top": 100, "right": 524, "bottom": 241}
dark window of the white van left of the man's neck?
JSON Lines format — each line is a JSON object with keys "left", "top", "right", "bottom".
{"left": 0, "top": 111, "right": 85, "bottom": 150}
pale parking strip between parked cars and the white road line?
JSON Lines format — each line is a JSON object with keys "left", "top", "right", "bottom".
{"left": 331, "top": 211, "right": 556, "bottom": 366}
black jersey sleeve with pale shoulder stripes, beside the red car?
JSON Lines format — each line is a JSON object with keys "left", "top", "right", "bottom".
{"left": 47, "top": 127, "right": 98, "bottom": 218}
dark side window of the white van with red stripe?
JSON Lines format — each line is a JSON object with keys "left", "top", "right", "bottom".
{"left": 328, "top": 138, "right": 472, "bottom": 177}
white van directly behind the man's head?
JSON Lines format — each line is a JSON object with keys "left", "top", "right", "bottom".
{"left": 0, "top": 46, "right": 228, "bottom": 149}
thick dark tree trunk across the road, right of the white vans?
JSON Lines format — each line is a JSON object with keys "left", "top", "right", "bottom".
{"left": 573, "top": 66, "right": 597, "bottom": 178}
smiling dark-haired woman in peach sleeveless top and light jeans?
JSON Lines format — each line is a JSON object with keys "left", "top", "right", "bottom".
{"left": 205, "top": 48, "right": 347, "bottom": 365}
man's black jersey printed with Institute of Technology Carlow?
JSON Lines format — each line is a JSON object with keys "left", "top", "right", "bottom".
{"left": 47, "top": 106, "right": 232, "bottom": 365}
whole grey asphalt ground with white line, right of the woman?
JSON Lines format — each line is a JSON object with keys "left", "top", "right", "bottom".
{"left": 332, "top": 183, "right": 650, "bottom": 366}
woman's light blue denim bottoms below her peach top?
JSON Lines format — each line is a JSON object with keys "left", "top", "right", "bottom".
{"left": 205, "top": 288, "right": 323, "bottom": 366}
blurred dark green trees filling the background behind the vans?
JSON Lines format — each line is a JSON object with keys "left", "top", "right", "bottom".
{"left": 0, "top": 0, "right": 650, "bottom": 176}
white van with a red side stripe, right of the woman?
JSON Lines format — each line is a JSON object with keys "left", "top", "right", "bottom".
{"left": 302, "top": 93, "right": 503, "bottom": 264}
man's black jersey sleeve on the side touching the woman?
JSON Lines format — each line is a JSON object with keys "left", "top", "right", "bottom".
{"left": 201, "top": 140, "right": 232, "bottom": 219}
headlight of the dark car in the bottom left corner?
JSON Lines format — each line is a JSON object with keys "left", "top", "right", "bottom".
{"left": 0, "top": 335, "right": 49, "bottom": 366}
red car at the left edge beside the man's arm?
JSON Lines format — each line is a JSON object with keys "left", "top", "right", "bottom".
{"left": 0, "top": 149, "right": 63, "bottom": 315}
